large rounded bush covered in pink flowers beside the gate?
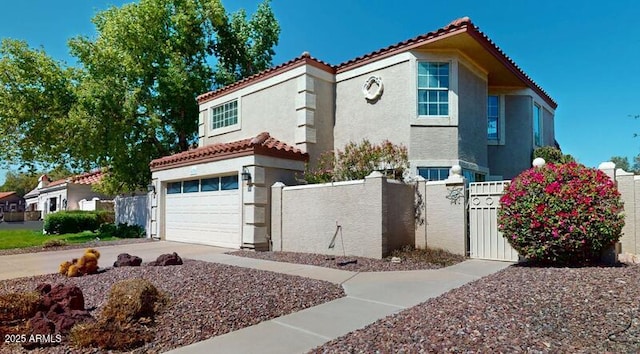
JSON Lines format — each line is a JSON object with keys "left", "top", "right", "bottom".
{"left": 498, "top": 162, "right": 624, "bottom": 264}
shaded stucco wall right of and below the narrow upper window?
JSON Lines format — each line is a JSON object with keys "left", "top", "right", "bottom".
{"left": 488, "top": 95, "right": 533, "bottom": 179}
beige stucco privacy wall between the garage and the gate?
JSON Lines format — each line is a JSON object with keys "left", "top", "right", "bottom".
{"left": 271, "top": 172, "right": 415, "bottom": 258}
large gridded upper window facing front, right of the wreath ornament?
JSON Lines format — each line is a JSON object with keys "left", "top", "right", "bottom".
{"left": 418, "top": 62, "right": 449, "bottom": 116}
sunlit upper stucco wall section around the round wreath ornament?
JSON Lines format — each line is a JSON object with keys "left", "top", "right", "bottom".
{"left": 334, "top": 61, "right": 416, "bottom": 149}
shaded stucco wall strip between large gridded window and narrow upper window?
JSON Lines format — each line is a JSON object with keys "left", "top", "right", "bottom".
{"left": 458, "top": 65, "right": 488, "bottom": 167}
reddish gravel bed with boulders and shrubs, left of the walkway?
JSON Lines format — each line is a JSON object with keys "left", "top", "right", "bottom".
{"left": 0, "top": 260, "right": 344, "bottom": 353}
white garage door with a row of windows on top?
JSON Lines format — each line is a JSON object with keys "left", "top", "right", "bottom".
{"left": 165, "top": 175, "right": 242, "bottom": 248}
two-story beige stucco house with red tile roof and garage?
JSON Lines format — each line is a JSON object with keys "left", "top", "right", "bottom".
{"left": 151, "top": 18, "right": 557, "bottom": 248}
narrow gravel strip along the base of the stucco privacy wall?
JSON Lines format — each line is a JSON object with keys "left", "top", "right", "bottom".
{"left": 227, "top": 251, "right": 464, "bottom": 272}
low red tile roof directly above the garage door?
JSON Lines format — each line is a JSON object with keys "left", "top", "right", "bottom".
{"left": 149, "top": 132, "right": 309, "bottom": 171}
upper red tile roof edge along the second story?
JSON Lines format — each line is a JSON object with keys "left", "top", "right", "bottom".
{"left": 197, "top": 17, "right": 558, "bottom": 109}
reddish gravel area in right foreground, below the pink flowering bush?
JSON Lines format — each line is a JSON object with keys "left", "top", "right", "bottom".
{"left": 312, "top": 265, "right": 640, "bottom": 353}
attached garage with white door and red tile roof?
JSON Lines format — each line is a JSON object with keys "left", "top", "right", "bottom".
{"left": 151, "top": 133, "right": 308, "bottom": 249}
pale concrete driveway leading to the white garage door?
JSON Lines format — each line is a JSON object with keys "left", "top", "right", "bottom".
{"left": 0, "top": 241, "right": 229, "bottom": 280}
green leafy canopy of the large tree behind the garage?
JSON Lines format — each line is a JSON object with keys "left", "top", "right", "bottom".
{"left": 0, "top": 0, "right": 280, "bottom": 193}
